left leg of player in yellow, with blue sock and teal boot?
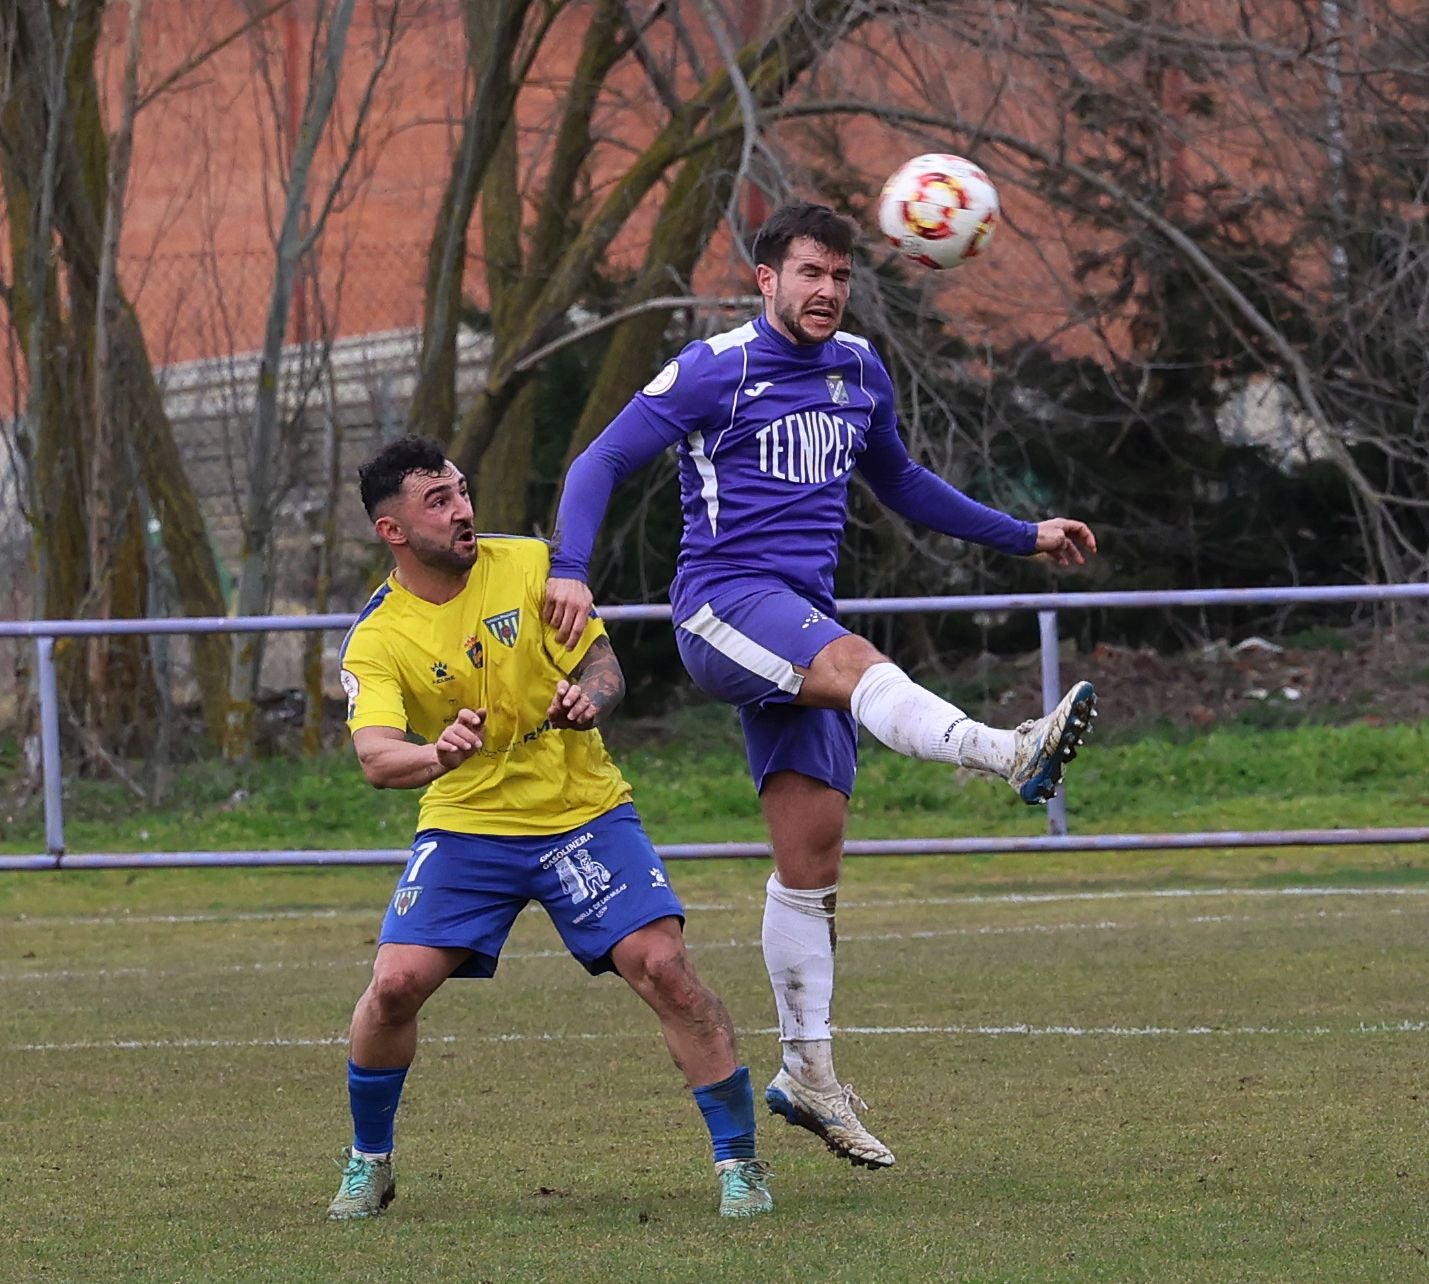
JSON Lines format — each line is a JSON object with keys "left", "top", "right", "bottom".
{"left": 327, "top": 944, "right": 469, "bottom": 1221}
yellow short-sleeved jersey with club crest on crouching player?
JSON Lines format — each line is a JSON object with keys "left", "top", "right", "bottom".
{"left": 339, "top": 536, "right": 630, "bottom": 836}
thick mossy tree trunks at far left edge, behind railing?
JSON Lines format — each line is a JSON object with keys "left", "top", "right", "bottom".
{"left": 0, "top": 0, "right": 227, "bottom": 759}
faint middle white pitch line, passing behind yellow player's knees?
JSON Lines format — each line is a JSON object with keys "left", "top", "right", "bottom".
{"left": 0, "top": 908, "right": 1403, "bottom": 985}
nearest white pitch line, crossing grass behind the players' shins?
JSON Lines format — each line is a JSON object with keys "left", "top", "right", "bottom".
{"left": 6, "top": 1021, "right": 1429, "bottom": 1053}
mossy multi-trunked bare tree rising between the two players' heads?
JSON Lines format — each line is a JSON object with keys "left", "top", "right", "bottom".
{"left": 412, "top": 0, "right": 882, "bottom": 528}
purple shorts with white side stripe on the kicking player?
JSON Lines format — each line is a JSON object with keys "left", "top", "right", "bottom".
{"left": 674, "top": 578, "right": 859, "bottom": 796}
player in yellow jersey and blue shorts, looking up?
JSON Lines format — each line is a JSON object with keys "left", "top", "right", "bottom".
{"left": 327, "top": 437, "right": 773, "bottom": 1220}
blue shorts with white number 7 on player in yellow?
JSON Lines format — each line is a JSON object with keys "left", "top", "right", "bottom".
{"left": 377, "top": 803, "right": 684, "bottom": 977}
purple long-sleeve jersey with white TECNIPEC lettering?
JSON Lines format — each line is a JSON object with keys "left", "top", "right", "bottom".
{"left": 552, "top": 317, "right": 1036, "bottom": 620}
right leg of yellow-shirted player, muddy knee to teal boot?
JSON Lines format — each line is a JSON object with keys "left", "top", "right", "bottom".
{"left": 610, "top": 917, "right": 775, "bottom": 1217}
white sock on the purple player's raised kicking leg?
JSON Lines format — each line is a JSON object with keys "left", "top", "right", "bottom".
{"left": 849, "top": 661, "right": 1017, "bottom": 776}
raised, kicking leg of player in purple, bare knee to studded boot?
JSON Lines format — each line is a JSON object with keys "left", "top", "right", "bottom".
{"left": 796, "top": 633, "right": 1096, "bottom": 804}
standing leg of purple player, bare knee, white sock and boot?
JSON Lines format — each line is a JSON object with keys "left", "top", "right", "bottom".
{"left": 759, "top": 771, "right": 893, "bottom": 1168}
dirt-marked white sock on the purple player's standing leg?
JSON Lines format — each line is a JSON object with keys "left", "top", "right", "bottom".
{"left": 763, "top": 874, "right": 839, "bottom": 1088}
